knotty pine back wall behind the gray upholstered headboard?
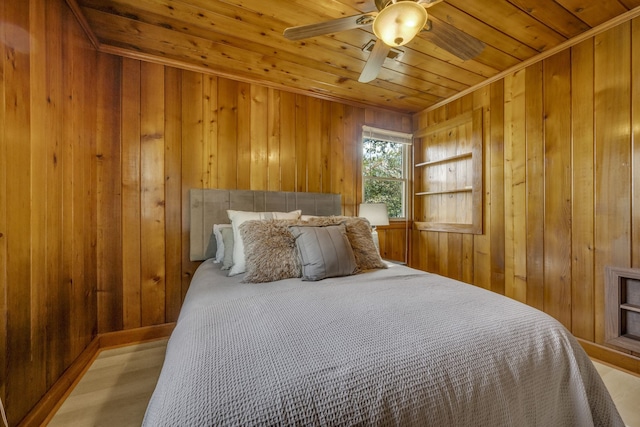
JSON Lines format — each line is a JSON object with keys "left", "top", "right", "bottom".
{"left": 98, "top": 59, "right": 412, "bottom": 332}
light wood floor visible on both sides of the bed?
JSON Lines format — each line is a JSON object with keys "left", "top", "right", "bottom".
{"left": 49, "top": 339, "right": 640, "bottom": 427}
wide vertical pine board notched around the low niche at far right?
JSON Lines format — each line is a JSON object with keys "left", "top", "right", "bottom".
{"left": 594, "top": 22, "right": 637, "bottom": 343}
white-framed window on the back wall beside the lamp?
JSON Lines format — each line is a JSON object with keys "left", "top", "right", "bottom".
{"left": 362, "top": 126, "right": 412, "bottom": 218}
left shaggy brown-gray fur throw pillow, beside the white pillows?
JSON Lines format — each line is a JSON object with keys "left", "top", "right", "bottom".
{"left": 240, "top": 220, "right": 300, "bottom": 283}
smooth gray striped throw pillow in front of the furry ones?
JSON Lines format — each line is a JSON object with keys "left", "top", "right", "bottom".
{"left": 289, "top": 224, "right": 356, "bottom": 281}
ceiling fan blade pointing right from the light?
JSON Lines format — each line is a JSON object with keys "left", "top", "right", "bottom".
{"left": 420, "top": 15, "right": 484, "bottom": 61}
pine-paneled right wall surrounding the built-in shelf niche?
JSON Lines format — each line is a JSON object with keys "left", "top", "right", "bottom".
{"left": 412, "top": 19, "right": 640, "bottom": 371}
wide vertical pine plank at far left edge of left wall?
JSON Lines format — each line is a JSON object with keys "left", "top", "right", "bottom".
{"left": 3, "top": 2, "right": 34, "bottom": 423}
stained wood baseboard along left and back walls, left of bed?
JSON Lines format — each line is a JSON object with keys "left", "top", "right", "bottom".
{"left": 18, "top": 323, "right": 175, "bottom": 427}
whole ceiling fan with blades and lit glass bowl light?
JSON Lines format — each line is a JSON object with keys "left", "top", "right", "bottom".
{"left": 284, "top": 0, "right": 484, "bottom": 83}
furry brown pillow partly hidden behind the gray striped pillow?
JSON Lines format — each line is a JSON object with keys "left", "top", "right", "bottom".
{"left": 307, "top": 216, "right": 387, "bottom": 271}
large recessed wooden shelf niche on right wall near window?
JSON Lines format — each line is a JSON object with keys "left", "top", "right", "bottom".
{"left": 414, "top": 109, "right": 483, "bottom": 234}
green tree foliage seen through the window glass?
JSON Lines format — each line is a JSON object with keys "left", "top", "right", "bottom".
{"left": 362, "top": 139, "right": 406, "bottom": 218}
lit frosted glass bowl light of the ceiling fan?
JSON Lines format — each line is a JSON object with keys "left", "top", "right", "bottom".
{"left": 373, "top": 1, "right": 427, "bottom": 46}
